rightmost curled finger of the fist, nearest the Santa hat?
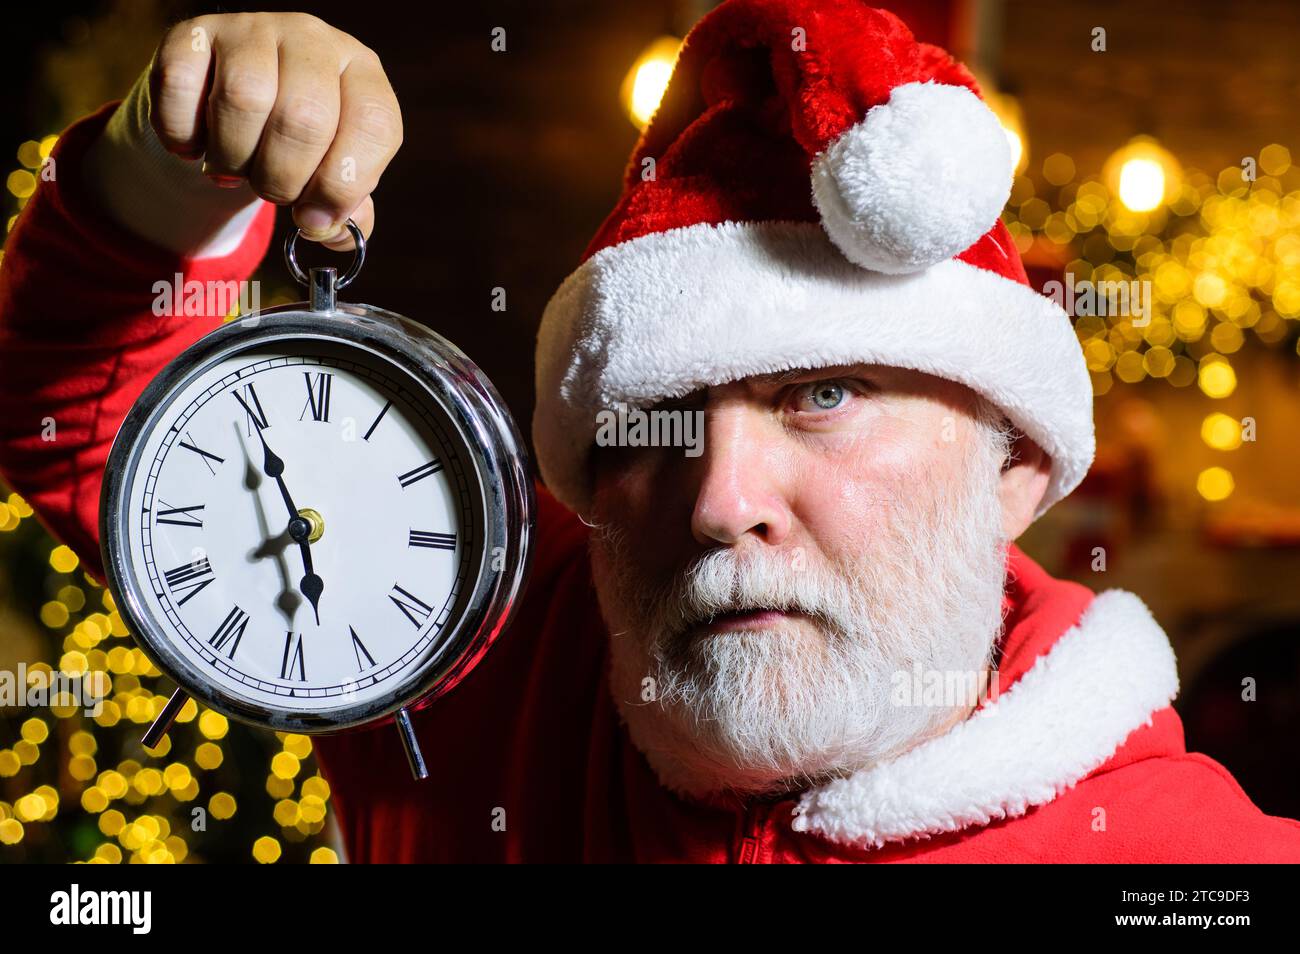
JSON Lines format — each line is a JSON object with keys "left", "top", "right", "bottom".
{"left": 294, "top": 49, "right": 402, "bottom": 247}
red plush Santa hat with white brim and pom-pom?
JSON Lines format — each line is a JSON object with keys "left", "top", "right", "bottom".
{"left": 533, "top": 0, "right": 1093, "bottom": 515}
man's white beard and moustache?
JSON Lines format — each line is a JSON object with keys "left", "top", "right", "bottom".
{"left": 592, "top": 419, "right": 1006, "bottom": 797}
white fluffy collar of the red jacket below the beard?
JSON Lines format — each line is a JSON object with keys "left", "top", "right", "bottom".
{"left": 793, "top": 590, "right": 1178, "bottom": 847}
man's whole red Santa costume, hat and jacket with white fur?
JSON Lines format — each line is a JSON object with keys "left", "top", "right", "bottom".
{"left": 0, "top": 0, "right": 1300, "bottom": 863}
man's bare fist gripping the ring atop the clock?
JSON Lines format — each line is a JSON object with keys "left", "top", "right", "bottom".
{"left": 150, "top": 13, "right": 402, "bottom": 250}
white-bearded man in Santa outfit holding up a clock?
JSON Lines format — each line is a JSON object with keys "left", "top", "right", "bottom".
{"left": 0, "top": 0, "right": 1300, "bottom": 862}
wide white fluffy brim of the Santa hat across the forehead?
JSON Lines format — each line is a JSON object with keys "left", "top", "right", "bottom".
{"left": 533, "top": 222, "right": 1093, "bottom": 515}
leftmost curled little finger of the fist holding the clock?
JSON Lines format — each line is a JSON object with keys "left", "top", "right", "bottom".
{"left": 150, "top": 17, "right": 216, "bottom": 159}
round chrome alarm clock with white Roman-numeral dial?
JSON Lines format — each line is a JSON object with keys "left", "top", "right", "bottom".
{"left": 100, "top": 221, "right": 534, "bottom": 777}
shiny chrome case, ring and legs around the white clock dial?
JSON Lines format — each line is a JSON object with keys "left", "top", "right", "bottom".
{"left": 99, "top": 222, "right": 536, "bottom": 777}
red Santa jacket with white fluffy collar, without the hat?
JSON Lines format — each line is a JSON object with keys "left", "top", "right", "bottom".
{"left": 0, "top": 104, "right": 1300, "bottom": 862}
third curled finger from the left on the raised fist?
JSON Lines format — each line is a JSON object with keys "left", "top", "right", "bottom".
{"left": 250, "top": 30, "right": 339, "bottom": 205}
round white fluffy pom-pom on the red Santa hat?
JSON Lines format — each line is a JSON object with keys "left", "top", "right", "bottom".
{"left": 813, "top": 82, "right": 1014, "bottom": 274}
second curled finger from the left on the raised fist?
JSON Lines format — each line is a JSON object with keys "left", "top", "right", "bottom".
{"left": 203, "top": 23, "right": 278, "bottom": 175}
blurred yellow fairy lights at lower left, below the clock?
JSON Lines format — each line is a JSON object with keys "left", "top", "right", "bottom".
{"left": 0, "top": 504, "right": 338, "bottom": 864}
